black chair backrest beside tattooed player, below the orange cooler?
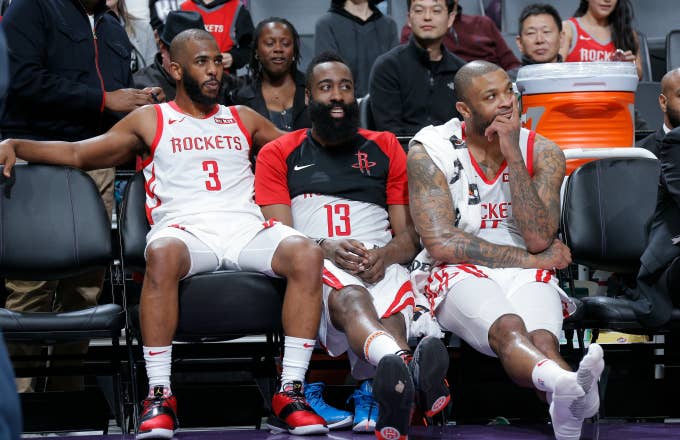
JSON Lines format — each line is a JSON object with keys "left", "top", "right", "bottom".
{"left": 561, "top": 158, "right": 659, "bottom": 273}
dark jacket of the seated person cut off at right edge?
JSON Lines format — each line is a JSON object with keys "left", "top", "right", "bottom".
{"left": 636, "top": 127, "right": 680, "bottom": 327}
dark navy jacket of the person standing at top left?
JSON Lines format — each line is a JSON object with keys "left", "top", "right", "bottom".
{"left": 1, "top": 0, "right": 132, "bottom": 141}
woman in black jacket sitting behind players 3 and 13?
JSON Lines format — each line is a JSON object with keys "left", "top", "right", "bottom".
{"left": 231, "top": 17, "right": 312, "bottom": 131}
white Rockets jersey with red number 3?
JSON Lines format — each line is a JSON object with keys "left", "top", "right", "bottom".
{"left": 143, "top": 101, "right": 264, "bottom": 254}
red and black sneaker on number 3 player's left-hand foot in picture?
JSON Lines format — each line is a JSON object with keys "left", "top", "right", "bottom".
{"left": 135, "top": 387, "right": 179, "bottom": 440}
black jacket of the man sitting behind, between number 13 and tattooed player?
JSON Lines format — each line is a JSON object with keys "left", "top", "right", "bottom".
{"left": 369, "top": 37, "right": 465, "bottom": 136}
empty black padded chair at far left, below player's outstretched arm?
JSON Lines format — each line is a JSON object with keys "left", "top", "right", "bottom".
{"left": 0, "top": 164, "right": 125, "bottom": 428}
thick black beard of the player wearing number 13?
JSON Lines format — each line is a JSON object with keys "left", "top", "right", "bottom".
{"left": 308, "top": 100, "right": 359, "bottom": 145}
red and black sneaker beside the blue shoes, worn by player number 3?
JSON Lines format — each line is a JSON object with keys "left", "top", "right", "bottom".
{"left": 267, "top": 381, "right": 328, "bottom": 435}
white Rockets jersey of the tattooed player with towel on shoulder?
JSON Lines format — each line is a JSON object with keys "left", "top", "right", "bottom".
{"left": 463, "top": 129, "right": 535, "bottom": 249}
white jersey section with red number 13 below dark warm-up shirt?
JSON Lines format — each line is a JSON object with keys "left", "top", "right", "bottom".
{"left": 291, "top": 194, "right": 392, "bottom": 247}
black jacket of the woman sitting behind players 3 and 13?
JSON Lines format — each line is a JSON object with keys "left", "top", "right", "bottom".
{"left": 231, "top": 71, "right": 312, "bottom": 131}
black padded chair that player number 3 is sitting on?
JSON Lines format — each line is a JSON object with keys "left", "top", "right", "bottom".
{"left": 120, "top": 173, "right": 284, "bottom": 425}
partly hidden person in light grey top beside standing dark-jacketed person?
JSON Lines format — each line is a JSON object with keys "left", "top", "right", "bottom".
{"left": 106, "top": 0, "right": 158, "bottom": 73}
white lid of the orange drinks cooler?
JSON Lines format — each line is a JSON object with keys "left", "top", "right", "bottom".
{"left": 516, "top": 61, "right": 638, "bottom": 95}
